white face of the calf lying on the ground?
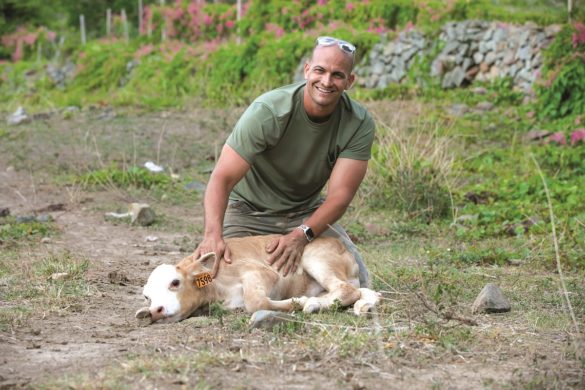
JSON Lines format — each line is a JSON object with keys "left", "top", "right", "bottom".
{"left": 137, "top": 264, "right": 185, "bottom": 322}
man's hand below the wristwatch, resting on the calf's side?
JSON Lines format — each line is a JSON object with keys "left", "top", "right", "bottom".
{"left": 266, "top": 229, "right": 308, "bottom": 276}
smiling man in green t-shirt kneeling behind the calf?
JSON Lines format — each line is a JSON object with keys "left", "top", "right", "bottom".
{"left": 195, "top": 37, "right": 375, "bottom": 287}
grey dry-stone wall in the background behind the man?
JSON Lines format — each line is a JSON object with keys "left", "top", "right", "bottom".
{"left": 356, "top": 20, "right": 560, "bottom": 92}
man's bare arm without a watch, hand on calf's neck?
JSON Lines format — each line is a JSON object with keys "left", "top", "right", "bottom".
{"left": 195, "top": 145, "right": 250, "bottom": 276}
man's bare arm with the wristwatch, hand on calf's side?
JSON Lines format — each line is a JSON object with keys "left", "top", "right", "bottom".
{"left": 266, "top": 158, "right": 368, "bottom": 275}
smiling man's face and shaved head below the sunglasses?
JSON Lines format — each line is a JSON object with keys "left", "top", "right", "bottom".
{"left": 305, "top": 45, "right": 355, "bottom": 113}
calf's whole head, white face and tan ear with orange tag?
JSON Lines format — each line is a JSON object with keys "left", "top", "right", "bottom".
{"left": 136, "top": 253, "right": 215, "bottom": 323}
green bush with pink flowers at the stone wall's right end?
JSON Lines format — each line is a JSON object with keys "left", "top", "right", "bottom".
{"left": 536, "top": 23, "right": 585, "bottom": 118}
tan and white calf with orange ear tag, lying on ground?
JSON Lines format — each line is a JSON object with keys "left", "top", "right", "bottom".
{"left": 136, "top": 235, "right": 379, "bottom": 322}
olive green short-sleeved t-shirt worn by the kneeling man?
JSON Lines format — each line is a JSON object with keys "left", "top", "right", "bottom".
{"left": 226, "top": 82, "right": 375, "bottom": 213}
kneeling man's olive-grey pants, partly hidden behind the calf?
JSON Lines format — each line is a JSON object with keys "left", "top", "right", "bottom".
{"left": 223, "top": 200, "right": 370, "bottom": 287}
